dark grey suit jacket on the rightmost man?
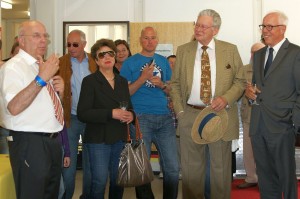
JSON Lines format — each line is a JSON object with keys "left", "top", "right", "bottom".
{"left": 250, "top": 39, "right": 300, "bottom": 135}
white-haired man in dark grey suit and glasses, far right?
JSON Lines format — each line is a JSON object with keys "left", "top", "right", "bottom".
{"left": 246, "top": 11, "right": 300, "bottom": 199}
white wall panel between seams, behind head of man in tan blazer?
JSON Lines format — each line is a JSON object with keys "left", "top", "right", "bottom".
{"left": 144, "top": 0, "right": 256, "bottom": 63}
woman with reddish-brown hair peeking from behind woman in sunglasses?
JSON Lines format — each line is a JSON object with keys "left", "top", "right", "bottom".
{"left": 115, "top": 39, "right": 131, "bottom": 73}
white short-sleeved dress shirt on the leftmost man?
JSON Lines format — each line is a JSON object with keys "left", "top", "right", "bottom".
{"left": 0, "top": 49, "right": 62, "bottom": 133}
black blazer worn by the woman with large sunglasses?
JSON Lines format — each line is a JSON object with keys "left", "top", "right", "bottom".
{"left": 77, "top": 71, "right": 133, "bottom": 144}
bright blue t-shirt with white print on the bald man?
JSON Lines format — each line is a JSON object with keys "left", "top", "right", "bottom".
{"left": 120, "top": 53, "right": 172, "bottom": 114}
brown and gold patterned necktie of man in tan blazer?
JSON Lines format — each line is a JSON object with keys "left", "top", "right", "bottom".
{"left": 200, "top": 46, "right": 211, "bottom": 104}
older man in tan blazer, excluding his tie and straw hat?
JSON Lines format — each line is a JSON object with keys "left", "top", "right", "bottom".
{"left": 171, "top": 9, "right": 245, "bottom": 199}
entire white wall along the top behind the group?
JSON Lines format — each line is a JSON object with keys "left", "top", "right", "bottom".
{"left": 31, "top": 0, "right": 300, "bottom": 64}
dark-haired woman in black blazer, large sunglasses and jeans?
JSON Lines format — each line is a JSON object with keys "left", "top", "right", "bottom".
{"left": 77, "top": 39, "right": 134, "bottom": 199}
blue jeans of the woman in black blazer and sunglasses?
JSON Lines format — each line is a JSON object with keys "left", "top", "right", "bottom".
{"left": 86, "top": 141, "right": 125, "bottom": 199}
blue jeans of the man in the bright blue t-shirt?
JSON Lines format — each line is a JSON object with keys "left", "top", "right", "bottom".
{"left": 132, "top": 114, "right": 179, "bottom": 199}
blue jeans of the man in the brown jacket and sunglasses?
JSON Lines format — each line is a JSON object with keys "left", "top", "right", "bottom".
{"left": 63, "top": 115, "right": 91, "bottom": 199}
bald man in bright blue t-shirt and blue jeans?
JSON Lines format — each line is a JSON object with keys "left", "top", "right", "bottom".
{"left": 120, "top": 27, "right": 179, "bottom": 199}
